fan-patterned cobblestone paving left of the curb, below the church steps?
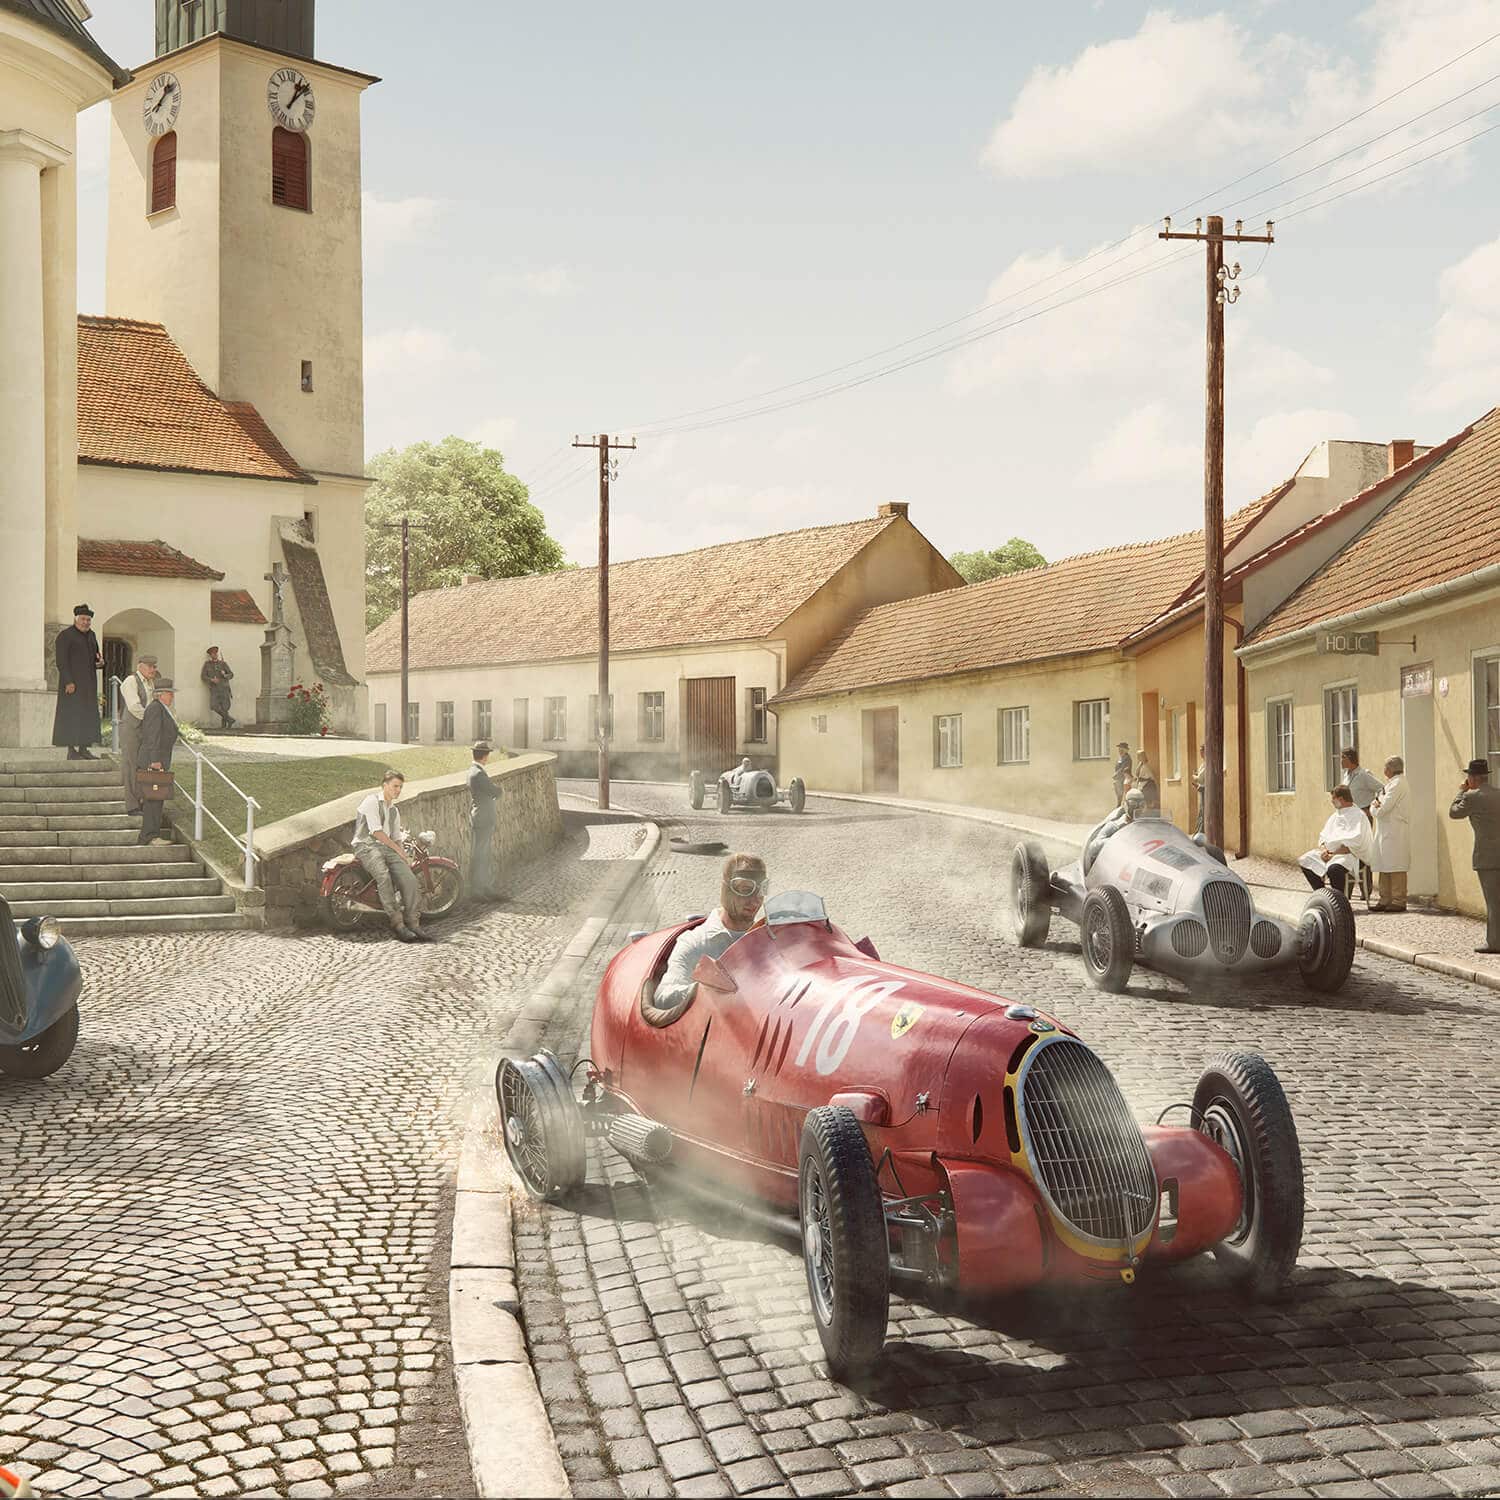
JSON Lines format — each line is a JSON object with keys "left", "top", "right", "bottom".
{"left": 0, "top": 819, "right": 641, "bottom": 1496}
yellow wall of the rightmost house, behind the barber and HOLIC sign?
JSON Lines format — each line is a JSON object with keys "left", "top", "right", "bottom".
{"left": 1247, "top": 591, "right": 1500, "bottom": 915}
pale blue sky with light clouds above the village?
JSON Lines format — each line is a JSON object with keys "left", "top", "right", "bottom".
{"left": 80, "top": 0, "right": 1500, "bottom": 564}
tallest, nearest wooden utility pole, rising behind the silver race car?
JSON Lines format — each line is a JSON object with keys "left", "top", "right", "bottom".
{"left": 1158, "top": 213, "right": 1275, "bottom": 848}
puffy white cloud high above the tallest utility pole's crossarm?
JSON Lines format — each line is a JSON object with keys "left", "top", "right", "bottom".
{"left": 984, "top": 11, "right": 1289, "bottom": 177}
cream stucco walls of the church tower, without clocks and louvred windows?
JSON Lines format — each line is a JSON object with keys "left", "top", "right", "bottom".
{"left": 107, "top": 38, "right": 366, "bottom": 474}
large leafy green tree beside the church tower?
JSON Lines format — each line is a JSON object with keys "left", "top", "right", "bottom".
{"left": 365, "top": 437, "right": 566, "bottom": 630}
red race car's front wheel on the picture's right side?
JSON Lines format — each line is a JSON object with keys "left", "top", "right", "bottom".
{"left": 1193, "top": 1052, "right": 1304, "bottom": 1298}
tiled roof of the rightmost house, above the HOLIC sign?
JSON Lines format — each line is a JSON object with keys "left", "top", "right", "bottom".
{"left": 1250, "top": 407, "right": 1500, "bottom": 645}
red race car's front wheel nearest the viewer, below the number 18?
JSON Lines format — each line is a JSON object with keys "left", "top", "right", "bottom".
{"left": 798, "top": 1104, "right": 891, "bottom": 1380}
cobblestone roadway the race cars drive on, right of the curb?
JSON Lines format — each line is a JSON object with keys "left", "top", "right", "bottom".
{"left": 518, "top": 786, "right": 1500, "bottom": 1497}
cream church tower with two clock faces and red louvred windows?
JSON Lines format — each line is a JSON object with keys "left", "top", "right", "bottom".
{"left": 107, "top": 0, "right": 377, "bottom": 482}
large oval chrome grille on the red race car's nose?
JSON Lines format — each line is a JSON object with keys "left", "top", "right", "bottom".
{"left": 1020, "top": 1037, "right": 1157, "bottom": 1247}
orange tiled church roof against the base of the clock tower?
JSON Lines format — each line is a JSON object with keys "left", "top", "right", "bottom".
{"left": 78, "top": 317, "right": 317, "bottom": 485}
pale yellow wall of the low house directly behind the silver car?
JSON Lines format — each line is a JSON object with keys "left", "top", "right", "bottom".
{"left": 777, "top": 653, "right": 1137, "bottom": 822}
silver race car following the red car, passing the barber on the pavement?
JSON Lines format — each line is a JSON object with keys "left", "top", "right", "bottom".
{"left": 1011, "top": 813, "right": 1355, "bottom": 992}
